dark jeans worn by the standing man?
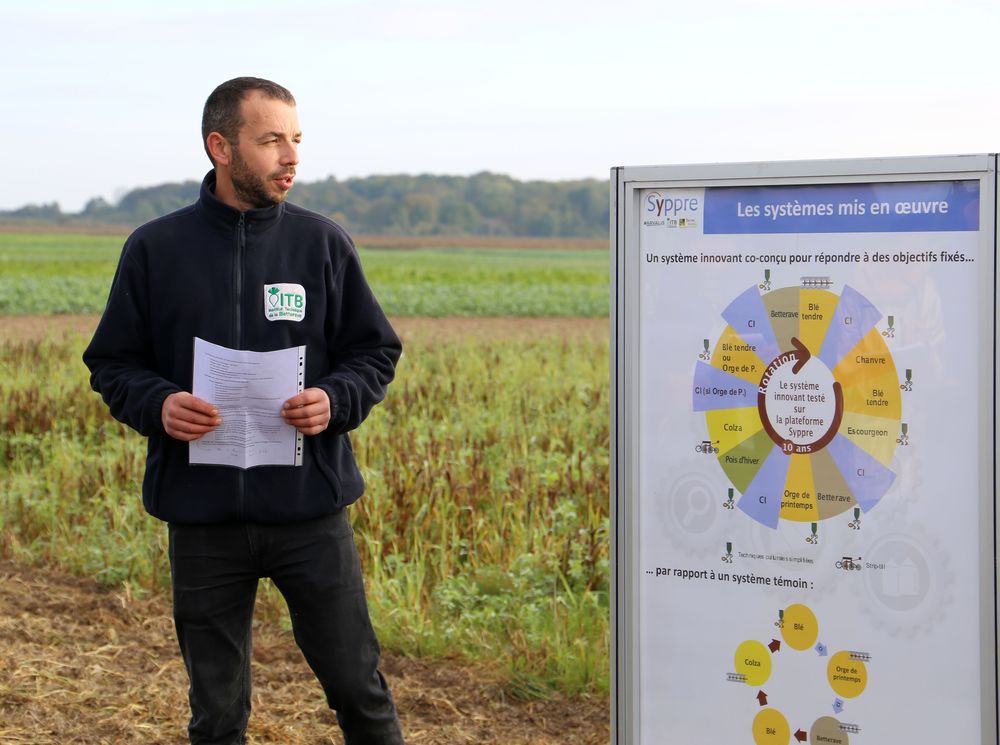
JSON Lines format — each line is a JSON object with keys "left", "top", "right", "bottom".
{"left": 170, "top": 510, "right": 403, "bottom": 745}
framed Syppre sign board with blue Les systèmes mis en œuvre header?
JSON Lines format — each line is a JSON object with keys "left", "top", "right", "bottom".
{"left": 611, "top": 155, "right": 997, "bottom": 745}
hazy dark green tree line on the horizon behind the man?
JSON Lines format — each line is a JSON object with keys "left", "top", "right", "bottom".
{"left": 0, "top": 172, "right": 609, "bottom": 238}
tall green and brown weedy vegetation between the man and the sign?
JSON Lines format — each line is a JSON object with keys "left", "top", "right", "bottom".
{"left": 358, "top": 339, "right": 608, "bottom": 693}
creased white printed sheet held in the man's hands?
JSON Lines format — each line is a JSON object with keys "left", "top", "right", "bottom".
{"left": 189, "top": 337, "right": 306, "bottom": 468}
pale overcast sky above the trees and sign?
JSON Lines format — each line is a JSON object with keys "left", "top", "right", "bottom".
{"left": 7, "top": 0, "right": 1000, "bottom": 211}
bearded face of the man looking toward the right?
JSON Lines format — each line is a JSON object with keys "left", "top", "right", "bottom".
{"left": 229, "top": 91, "right": 302, "bottom": 209}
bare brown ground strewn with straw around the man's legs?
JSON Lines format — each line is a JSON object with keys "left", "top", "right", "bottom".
{"left": 0, "top": 562, "right": 608, "bottom": 745}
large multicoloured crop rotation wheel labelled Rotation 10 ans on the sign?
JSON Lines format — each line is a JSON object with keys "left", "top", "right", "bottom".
{"left": 694, "top": 286, "right": 902, "bottom": 528}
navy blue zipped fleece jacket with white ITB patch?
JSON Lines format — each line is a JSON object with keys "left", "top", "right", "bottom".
{"left": 83, "top": 172, "right": 401, "bottom": 523}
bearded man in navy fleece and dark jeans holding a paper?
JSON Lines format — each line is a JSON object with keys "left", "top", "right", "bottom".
{"left": 84, "top": 78, "right": 403, "bottom": 745}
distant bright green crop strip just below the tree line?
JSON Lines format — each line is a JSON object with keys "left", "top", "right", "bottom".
{"left": 0, "top": 233, "right": 608, "bottom": 317}
